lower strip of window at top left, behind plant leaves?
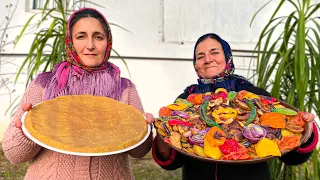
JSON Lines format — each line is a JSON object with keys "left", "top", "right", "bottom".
{"left": 30, "top": 0, "right": 88, "bottom": 10}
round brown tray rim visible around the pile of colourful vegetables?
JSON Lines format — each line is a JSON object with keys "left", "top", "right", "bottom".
{"left": 159, "top": 101, "right": 312, "bottom": 164}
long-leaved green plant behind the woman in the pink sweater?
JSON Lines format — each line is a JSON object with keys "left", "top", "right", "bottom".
{"left": 15, "top": 0, "right": 128, "bottom": 85}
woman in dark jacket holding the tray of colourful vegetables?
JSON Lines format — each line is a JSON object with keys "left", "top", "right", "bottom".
{"left": 152, "top": 33, "right": 318, "bottom": 180}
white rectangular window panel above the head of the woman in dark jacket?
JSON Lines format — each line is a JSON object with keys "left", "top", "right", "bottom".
{"left": 160, "top": 0, "right": 268, "bottom": 44}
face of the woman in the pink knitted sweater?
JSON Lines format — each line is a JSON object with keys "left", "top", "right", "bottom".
{"left": 72, "top": 17, "right": 107, "bottom": 67}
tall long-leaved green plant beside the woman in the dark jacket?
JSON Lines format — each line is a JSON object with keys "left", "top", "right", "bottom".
{"left": 252, "top": 0, "right": 320, "bottom": 179}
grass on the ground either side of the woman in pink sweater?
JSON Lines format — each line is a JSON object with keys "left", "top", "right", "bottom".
{"left": 0, "top": 144, "right": 181, "bottom": 180}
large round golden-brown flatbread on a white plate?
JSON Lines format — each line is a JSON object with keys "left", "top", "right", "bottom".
{"left": 24, "top": 95, "right": 148, "bottom": 153}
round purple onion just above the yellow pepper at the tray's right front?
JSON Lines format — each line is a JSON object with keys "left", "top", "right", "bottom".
{"left": 242, "top": 124, "right": 267, "bottom": 143}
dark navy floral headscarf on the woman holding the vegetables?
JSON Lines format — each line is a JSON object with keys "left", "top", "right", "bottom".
{"left": 185, "top": 33, "right": 253, "bottom": 93}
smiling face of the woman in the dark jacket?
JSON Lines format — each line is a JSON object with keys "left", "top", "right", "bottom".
{"left": 196, "top": 38, "right": 226, "bottom": 79}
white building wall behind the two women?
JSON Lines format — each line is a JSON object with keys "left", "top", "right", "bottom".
{"left": 0, "top": 0, "right": 319, "bottom": 140}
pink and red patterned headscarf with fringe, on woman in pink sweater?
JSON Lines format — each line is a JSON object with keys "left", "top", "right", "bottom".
{"left": 37, "top": 8, "right": 125, "bottom": 100}
